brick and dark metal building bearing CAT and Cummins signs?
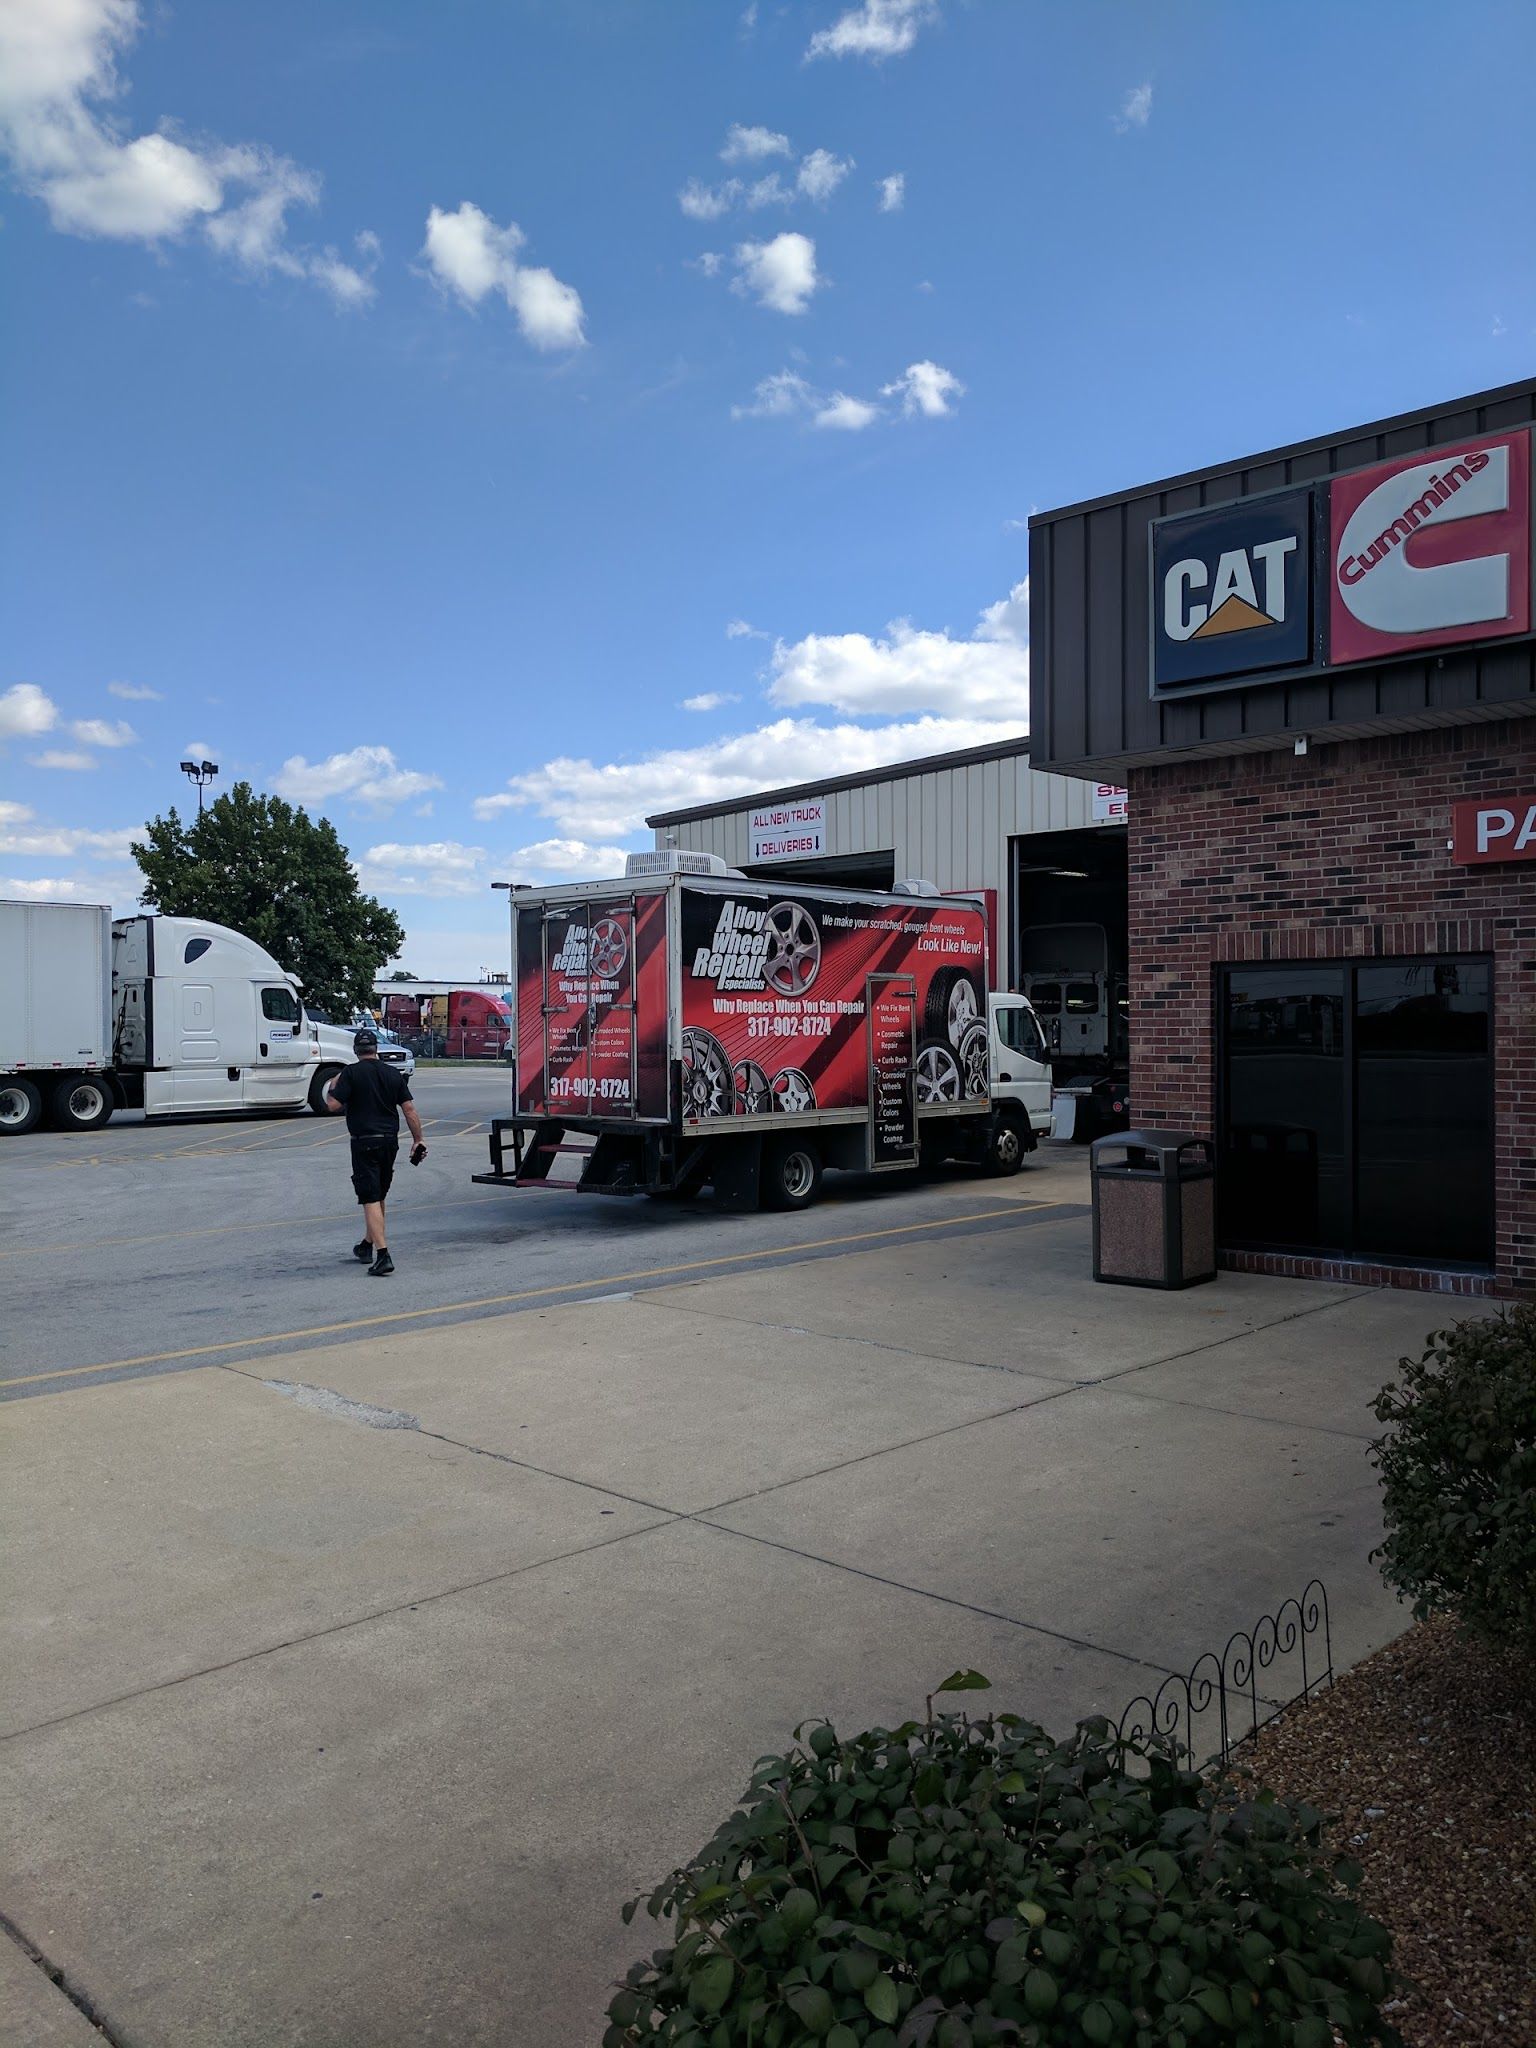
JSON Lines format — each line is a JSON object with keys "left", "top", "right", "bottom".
{"left": 1030, "top": 381, "right": 1536, "bottom": 1294}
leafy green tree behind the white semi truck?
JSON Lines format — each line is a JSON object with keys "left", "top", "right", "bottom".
{"left": 133, "top": 782, "right": 406, "bottom": 1016}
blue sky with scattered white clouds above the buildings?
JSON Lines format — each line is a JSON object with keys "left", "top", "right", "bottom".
{"left": 0, "top": 0, "right": 1536, "bottom": 975}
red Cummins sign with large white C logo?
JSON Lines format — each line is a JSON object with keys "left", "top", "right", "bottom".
{"left": 1329, "top": 428, "right": 1530, "bottom": 662}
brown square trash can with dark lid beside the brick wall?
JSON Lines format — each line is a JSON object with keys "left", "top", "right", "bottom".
{"left": 1092, "top": 1130, "right": 1217, "bottom": 1286}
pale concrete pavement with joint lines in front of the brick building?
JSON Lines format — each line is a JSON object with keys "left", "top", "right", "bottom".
{"left": 0, "top": 1167, "right": 1444, "bottom": 2048}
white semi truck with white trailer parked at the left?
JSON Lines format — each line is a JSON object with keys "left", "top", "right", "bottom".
{"left": 0, "top": 903, "right": 322, "bottom": 1137}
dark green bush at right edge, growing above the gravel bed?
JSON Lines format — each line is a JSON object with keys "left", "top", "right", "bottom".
{"left": 1372, "top": 1307, "right": 1536, "bottom": 1655}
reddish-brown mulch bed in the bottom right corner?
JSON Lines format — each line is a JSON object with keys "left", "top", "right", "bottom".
{"left": 1239, "top": 1620, "right": 1536, "bottom": 2048}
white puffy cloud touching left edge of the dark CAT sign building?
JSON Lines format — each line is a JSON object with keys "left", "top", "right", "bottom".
{"left": 768, "top": 584, "right": 1030, "bottom": 731}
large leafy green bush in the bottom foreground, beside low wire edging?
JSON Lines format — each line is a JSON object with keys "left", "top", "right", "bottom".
{"left": 604, "top": 1673, "right": 1397, "bottom": 2048}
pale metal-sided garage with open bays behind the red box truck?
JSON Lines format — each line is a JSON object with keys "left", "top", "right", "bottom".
{"left": 645, "top": 739, "right": 1124, "bottom": 987}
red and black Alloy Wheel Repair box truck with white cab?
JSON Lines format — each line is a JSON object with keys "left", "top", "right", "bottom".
{"left": 475, "top": 852, "right": 1051, "bottom": 1208}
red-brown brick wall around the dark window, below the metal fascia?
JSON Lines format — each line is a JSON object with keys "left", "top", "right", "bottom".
{"left": 1128, "top": 719, "right": 1536, "bottom": 1292}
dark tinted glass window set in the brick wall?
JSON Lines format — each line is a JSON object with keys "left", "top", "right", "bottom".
{"left": 1221, "top": 958, "right": 1493, "bottom": 1266}
